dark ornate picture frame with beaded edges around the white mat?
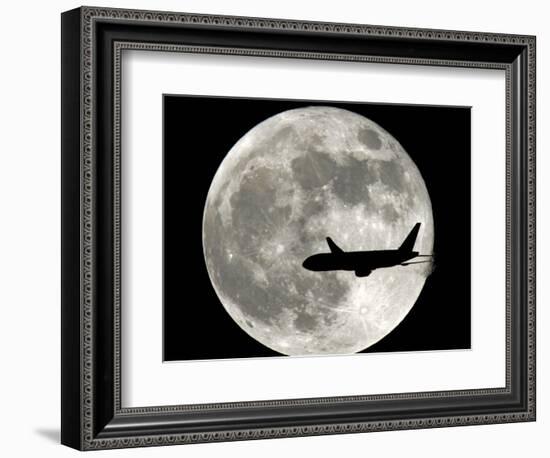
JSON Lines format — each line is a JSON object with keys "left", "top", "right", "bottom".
{"left": 61, "top": 7, "right": 535, "bottom": 450}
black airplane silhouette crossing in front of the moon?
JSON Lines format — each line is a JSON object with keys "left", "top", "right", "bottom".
{"left": 302, "top": 223, "right": 432, "bottom": 277}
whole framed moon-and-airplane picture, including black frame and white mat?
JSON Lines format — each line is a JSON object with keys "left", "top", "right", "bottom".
{"left": 62, "top": 7, "right": 535, "bottom": 450}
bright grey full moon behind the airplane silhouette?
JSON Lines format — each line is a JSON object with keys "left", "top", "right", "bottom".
{"left": 203, "top": 106, "right": 434, "bottom": 355}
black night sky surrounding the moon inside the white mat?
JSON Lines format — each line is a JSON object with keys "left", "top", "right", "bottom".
{"left": 163, "top": 95, "right": 471, "bottom": 361}
